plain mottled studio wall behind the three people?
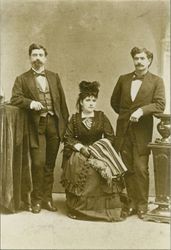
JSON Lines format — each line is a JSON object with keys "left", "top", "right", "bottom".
{"left": 1, "top": 0, "right": 169, "bottom": 194}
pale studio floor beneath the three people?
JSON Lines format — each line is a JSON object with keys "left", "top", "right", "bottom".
{"left": 1, "top": 194, "right": 170, "bottom": 250}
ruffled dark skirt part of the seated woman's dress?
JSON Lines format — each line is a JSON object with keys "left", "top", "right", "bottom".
{"left": 61, "top": 152, "right": 123, "bottom": 221}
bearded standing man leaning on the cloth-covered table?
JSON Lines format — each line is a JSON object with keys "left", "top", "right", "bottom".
{"left": 11, "top": 44, "right": 68, "bottom": 213}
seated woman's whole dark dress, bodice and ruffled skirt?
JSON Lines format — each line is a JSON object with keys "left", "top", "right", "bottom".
{"left": 61, "top": 111, "right": 122, "bottom": 221}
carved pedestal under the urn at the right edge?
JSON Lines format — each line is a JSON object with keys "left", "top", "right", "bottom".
{"left": 144, "top": 143, "right": 171, "bottom": 223}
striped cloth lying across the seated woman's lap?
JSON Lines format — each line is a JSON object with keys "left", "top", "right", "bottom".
{"left": 89, "top": 138, "right": 127, "bottom": 178}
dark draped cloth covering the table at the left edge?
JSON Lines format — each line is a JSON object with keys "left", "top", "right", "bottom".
{"left": 0, "top": 104, "right": 32, "bottom": 212}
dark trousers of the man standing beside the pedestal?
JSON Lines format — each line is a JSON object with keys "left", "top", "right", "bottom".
{"left": 120, "top": 123, "right": 149, "bottom": 211}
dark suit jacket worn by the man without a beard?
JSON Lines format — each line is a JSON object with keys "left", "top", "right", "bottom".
{"left": 111, "top": 72, "right": 165, "bottom": 155}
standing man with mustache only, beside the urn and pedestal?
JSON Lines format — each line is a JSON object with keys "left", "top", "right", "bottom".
{"left": 111, "top": 47, "right": 165, "bottom": 219}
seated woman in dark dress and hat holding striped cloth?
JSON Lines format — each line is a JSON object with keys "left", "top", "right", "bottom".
{"left": 61, "top": 81, "right": 126, "bottom": 221}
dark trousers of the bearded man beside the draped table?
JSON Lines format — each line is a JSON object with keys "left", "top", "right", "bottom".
{"left": 31, "top": 114, "right": 60, "bottom": 204}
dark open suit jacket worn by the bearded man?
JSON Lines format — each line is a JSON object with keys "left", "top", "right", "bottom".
{"left": 11, "top": 70, "right": 69, "bottom": 147}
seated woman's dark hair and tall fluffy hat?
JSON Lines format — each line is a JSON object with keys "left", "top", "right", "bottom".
{"left": 76, "top": 81, "right": 100, "bottom": 112}
